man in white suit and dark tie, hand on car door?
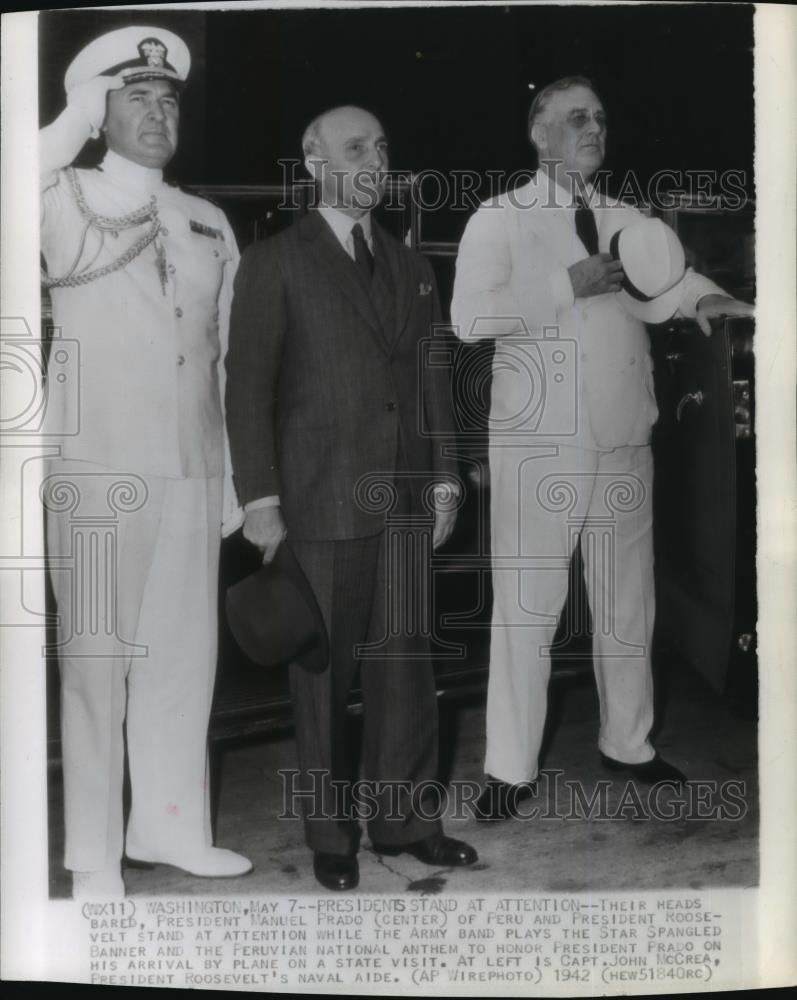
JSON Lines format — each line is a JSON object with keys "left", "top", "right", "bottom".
{"left": 451, "top": 77, "right": 750, "bottom": 820}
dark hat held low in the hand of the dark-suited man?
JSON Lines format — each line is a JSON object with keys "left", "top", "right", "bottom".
{"left": 226, "top": 542, "right": 329, "bottom": 673}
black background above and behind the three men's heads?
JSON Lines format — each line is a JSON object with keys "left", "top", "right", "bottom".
{"left": 40, "top": 4, "right": 753, "bottom": 225}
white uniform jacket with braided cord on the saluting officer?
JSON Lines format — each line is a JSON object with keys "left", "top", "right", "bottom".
{"left": 41, "top": 153, "right": 238, "bottom": 478}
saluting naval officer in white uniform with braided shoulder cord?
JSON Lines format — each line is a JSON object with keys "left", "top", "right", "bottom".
{"left": 40, "top": 27, "right": 251, "bottom": 898}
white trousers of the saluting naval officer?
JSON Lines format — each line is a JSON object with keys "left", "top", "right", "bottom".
{"left": 43, "top": 461, "right": 221, "bottom": 871}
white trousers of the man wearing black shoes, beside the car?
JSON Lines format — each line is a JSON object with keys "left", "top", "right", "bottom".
{"left": 485, "top": 436, "right": 655, "bottom": 783}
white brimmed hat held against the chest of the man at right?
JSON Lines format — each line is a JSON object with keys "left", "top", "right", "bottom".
{"left": 609, "top": 219, "right": 685, "bottom": 323}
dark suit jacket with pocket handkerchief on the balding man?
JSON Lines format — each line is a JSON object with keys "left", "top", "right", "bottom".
{"left": 226, "top": 211, "right": 456, "bottom": 540}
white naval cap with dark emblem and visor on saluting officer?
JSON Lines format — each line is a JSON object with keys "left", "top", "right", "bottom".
{"left": 64, "top": 27, "right": 191, "bottom": 93}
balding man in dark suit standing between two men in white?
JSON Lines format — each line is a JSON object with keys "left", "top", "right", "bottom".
{"left": 226, "top": 107, "right": 476, "bottom": 889}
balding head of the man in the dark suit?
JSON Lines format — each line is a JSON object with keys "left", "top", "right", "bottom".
{"left": 302, "top": 105, "right": 388, "bottom": 217}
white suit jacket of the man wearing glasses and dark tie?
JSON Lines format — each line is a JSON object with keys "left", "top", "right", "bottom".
{"left": 451, "top": 171, "right": 723, "bottom": 450}
